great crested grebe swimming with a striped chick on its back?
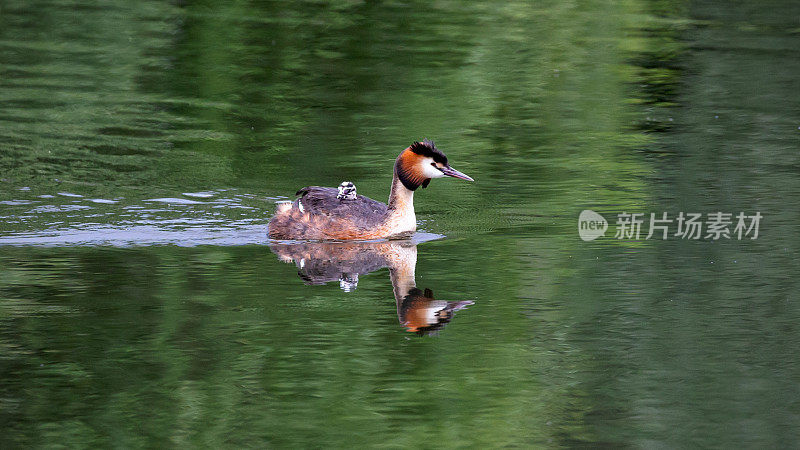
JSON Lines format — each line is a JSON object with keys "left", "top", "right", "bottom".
{"left": 269, "top": 139, "right": 473, "bottom": 240}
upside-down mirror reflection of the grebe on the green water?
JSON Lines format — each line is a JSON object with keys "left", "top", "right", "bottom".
{"left": 270, "top": 241, "right": 474, "bottom": 335}
